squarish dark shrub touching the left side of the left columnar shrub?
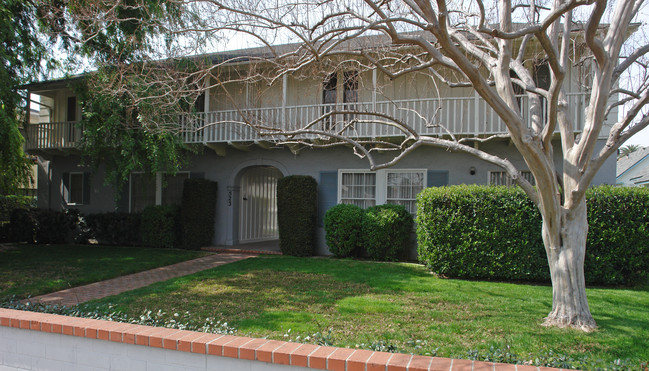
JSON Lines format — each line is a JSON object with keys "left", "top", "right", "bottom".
{"left": 140, "top": 205, "right": 180, "bottom": 248}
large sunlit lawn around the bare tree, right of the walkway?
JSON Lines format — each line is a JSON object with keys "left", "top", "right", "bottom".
{"left": 85, "top": 256, "right": 649, "bottom": 362}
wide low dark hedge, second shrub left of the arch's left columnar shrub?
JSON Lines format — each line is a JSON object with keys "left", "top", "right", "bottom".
{"left": 84, "top": 213, "right": 141, "bottom": 246}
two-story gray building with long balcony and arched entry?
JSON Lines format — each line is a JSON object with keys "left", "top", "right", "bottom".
{"left": 26, "top": 40, "right": 615, "bottom": 252}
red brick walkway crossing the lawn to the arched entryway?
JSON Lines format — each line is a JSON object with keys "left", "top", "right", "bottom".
{"left": 29, "top": 254, "right": 255, "bottom": 306}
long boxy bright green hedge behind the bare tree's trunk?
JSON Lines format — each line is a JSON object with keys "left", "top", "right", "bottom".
{"left": 417, "top": 185, "right": 649, "bottom": 285}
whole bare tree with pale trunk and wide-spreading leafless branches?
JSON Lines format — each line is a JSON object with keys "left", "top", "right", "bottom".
{"left": 40, "top": 0, "right": 649, "bottom": 331}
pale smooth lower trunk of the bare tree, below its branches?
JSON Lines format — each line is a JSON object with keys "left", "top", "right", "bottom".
{"left": 543, "top": 197, "right": 597, "bottom": 331}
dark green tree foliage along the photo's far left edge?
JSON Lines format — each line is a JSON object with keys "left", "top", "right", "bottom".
{"left": 0, "top": 0, "right": 46, "bottom": 195}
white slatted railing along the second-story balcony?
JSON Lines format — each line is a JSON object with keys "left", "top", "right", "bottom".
{"left": 26, "top": 93, "right": 588, "bottom": 150}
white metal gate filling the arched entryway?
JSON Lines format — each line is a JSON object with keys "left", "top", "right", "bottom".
{"left": 239, "top": 166, "right": 282, "bottom": 243}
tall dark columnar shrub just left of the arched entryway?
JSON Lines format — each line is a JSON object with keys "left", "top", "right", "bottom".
{"left": 180, "top": 179, "right": 217, "bottom": 249}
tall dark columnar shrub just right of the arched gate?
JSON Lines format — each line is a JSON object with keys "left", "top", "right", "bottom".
{"left": 277, "top": 175, "right": 318, "bottom": 256}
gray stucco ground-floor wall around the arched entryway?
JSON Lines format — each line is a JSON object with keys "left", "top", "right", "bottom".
{"left": 38, "top": 141, "right": 615, "bottom": 253}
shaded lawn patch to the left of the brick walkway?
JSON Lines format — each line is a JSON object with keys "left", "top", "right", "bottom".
{"left": 0, "top": 245, "right": 205, "bottom": 299}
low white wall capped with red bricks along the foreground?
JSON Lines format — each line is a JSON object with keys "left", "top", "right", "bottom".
{"left": 0, "top": 308, "right": 549, "bottom": 371}
